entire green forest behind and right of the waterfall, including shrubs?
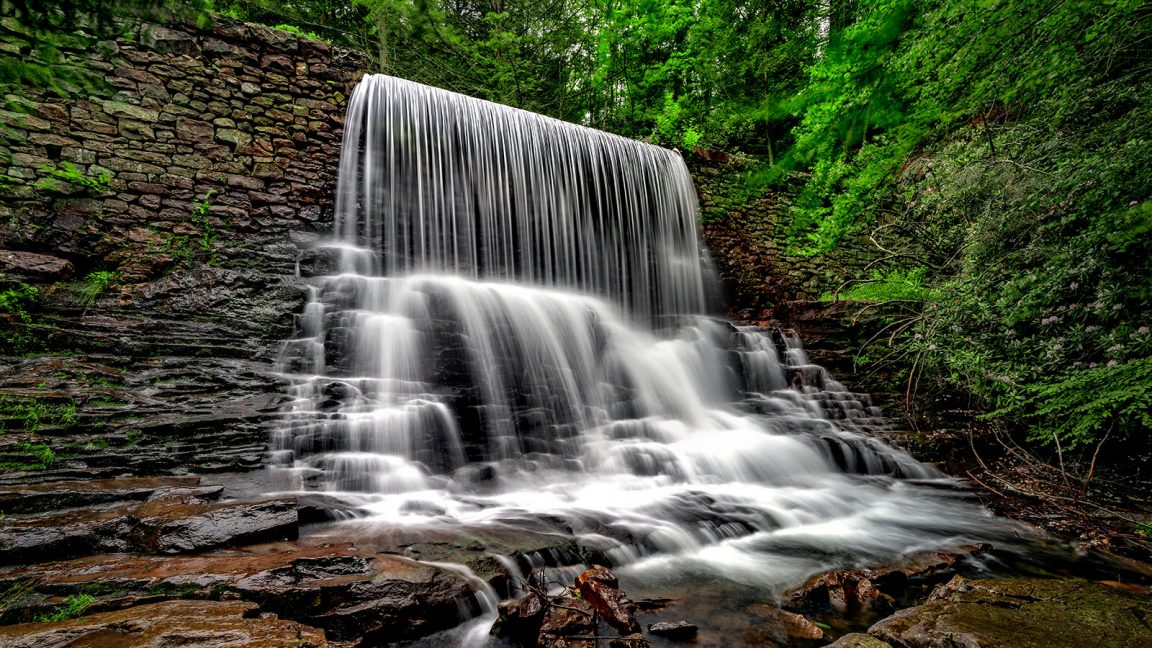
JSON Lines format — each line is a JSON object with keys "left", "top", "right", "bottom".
{"left": 9, "top": 0, "right": 1152, "bottom": 484}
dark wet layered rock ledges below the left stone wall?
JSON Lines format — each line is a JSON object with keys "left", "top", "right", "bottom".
{"left": 0, "top": 352, "right": 287, "bottom": 475}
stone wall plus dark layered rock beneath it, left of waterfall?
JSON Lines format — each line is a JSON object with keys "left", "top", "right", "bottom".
{"left": 0, "top": 18, "right": 365, "bottom": 475}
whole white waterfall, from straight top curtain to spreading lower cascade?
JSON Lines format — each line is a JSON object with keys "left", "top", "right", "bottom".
{"left": 271, "top": 76, "right": 1018, "bottom": 641}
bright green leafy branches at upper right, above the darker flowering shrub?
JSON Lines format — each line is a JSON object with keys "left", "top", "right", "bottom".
{"left": 774, "top": 0, "right": 1149, "bottom": 250}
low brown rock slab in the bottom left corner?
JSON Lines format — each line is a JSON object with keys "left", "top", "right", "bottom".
{"left": 0, "top": 601, "right": 328, "bottom": 648}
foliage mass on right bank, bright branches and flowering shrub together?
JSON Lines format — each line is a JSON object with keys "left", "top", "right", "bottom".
{"left": 797, "top": 0, "right": 1152, "bottom": 460}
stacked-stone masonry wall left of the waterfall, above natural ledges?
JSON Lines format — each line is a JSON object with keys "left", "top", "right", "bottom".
{"left": 0, "top": 13, "right": 364, "bottom": 348}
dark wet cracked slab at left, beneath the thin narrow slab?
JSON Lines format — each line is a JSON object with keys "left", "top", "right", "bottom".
{"left": 0, "top": 497, "right": 298, "bottom": 564}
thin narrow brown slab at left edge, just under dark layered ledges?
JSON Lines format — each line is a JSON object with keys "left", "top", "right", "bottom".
{"left": 0, "top": 477, "right": 216, "bottom": 515}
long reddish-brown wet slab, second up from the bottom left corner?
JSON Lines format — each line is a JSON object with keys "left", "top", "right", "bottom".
{"left": 0, "top": 542, "right": 475, "bottom": 645}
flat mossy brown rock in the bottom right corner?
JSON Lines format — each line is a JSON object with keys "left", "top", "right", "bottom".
{"left": 869, "top": 577, "right": 1152, "bottom": 648}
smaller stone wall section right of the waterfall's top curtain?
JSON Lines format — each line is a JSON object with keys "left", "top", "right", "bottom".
{"left": 685, "top": 150, "right": 878, "bottom": 319}
